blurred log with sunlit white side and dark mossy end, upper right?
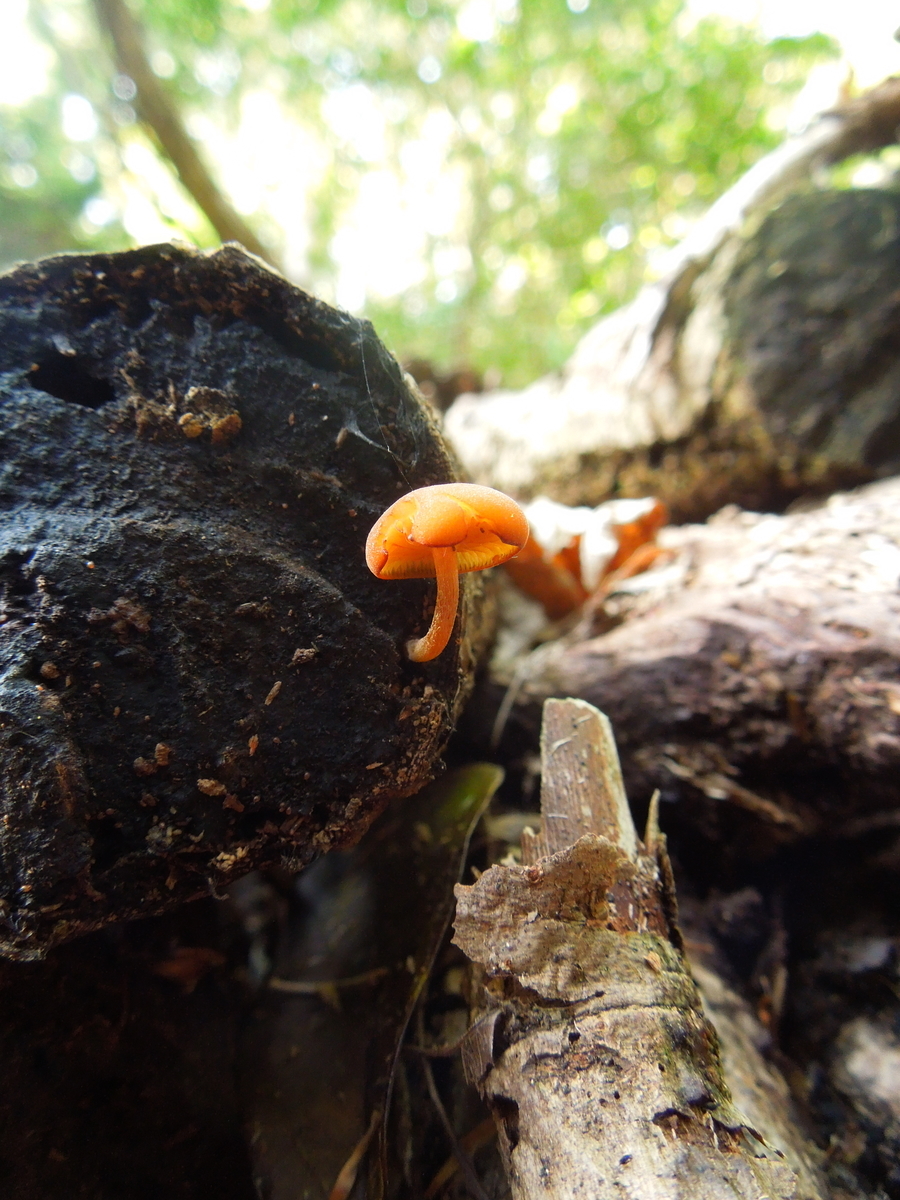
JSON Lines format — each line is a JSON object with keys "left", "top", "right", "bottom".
{"left": 446, "top": 79, "right": 900, "bottom": 521}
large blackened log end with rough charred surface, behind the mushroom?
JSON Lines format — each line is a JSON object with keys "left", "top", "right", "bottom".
{"left": 0, "top": 245, "right": 484, "bottom": 955}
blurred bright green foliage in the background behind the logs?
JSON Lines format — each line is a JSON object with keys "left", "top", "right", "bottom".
{"left": 0, "top": 0, "right": 834, "bottom": 385}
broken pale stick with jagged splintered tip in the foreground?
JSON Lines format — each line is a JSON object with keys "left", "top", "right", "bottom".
{"left": 454, "top": 700, "right": 824, "bottom": 1200}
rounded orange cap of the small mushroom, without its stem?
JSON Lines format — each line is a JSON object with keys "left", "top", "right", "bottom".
{"left": 366, "top": 484, "right": 528, "bottom": 580}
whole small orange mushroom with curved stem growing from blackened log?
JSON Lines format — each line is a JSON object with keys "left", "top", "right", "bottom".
{"left": 366, "top": 484, "right": 528, "bottom": 662}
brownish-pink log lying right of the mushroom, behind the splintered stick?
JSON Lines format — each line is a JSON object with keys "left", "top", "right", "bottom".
{"left": 498, "top": 479, "right": 900, "bottom": 865}
